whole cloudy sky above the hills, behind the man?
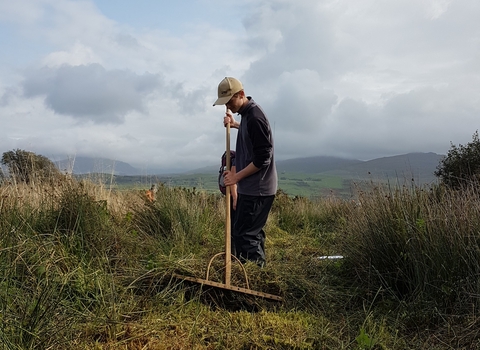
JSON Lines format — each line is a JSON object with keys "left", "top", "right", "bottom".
{"left": 0, "top": 0, "right": 480, "bottom": 173}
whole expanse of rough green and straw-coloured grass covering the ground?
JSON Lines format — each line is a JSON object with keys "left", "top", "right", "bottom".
{"left": 0, "top": 178, "right": 480, "bottom": 349}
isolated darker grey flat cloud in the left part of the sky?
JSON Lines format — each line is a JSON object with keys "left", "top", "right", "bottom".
{"left": 23, "top": 64, "right": 162, "bottom": 123}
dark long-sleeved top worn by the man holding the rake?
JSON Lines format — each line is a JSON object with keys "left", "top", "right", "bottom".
{"left": 235, "top": 96, "right": 277, "bottom": 196}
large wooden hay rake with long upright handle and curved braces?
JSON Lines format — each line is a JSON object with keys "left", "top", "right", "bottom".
{"left": 173, "top": 109, "right": 282, "bottom": 301}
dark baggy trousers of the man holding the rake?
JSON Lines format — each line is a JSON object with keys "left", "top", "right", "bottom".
{"left": 232, "top": 193, "right": 275, "bottom": 266}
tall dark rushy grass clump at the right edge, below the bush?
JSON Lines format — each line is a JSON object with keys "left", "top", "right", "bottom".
{"left": 343, "top": 180, "right": 480, "bottom": 336}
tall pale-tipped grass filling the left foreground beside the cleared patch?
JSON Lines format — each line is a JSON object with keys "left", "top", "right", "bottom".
{"left": 0, "top": 179, "right": 159, "bottom": 349}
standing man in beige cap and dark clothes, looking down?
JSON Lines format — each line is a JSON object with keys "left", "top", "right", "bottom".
{"left": 213, "top": 77, "right": 277, "bottom": 267}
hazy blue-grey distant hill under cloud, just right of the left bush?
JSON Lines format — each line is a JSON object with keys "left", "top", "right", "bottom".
{"left": 55, "top": 157, "right": 141, "bottom": 176}
